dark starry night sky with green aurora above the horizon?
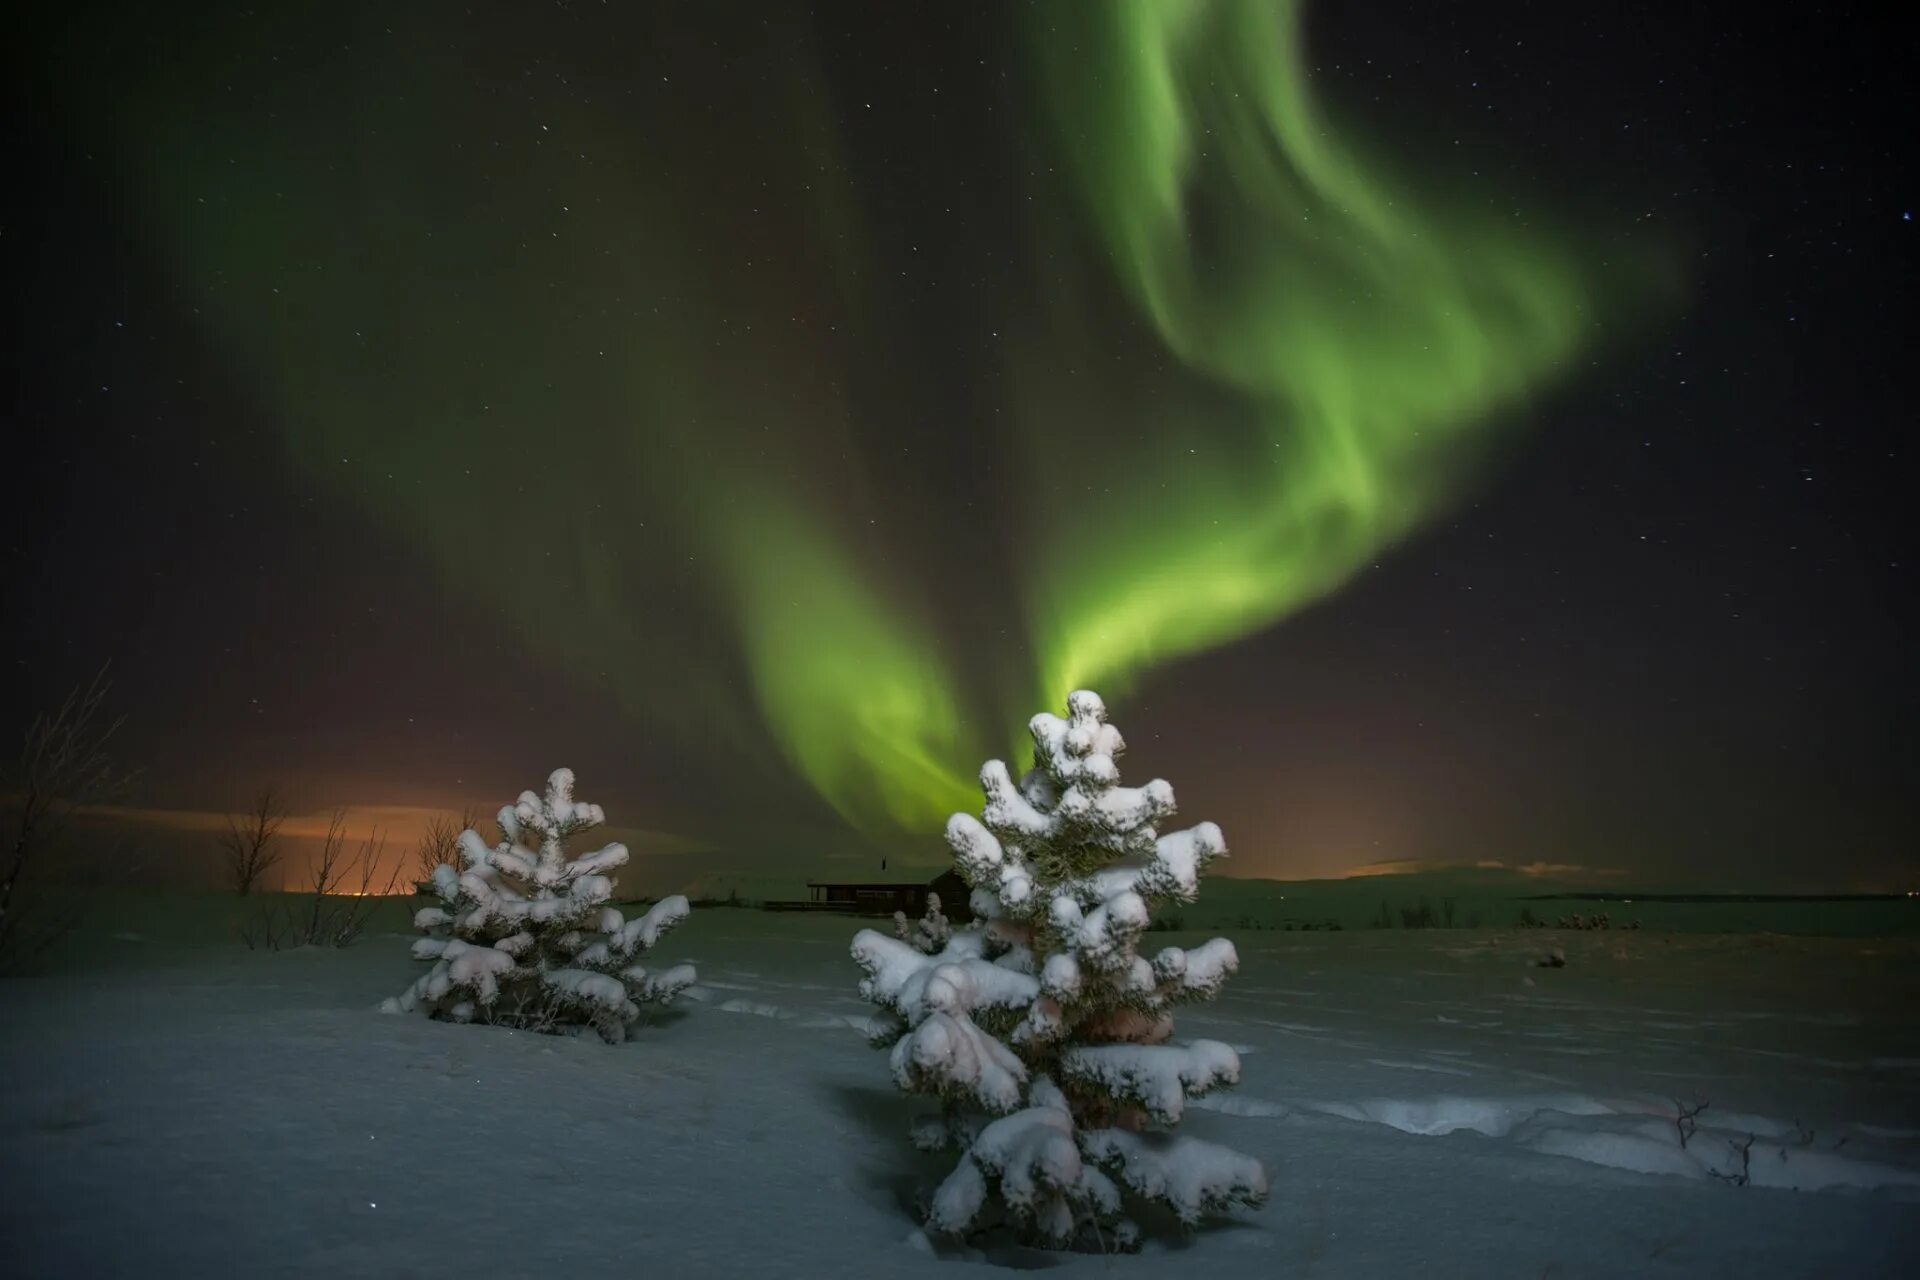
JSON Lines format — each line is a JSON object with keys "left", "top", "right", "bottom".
{"left": 0, "top": 2, "right": 1920, "bottom": 890}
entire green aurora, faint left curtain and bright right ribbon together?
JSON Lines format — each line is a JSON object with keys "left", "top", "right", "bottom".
{"left": 52, "top": 2, "right": 1659, "bottom": 833}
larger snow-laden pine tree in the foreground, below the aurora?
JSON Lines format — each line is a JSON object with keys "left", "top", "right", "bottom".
{"left": 852, "top": 691, "right": 1267, "bottom": 1249}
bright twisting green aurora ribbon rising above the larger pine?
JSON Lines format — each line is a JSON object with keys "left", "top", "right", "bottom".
{"left": 1031, "top": 4, "right": 1635, "bottom": 702}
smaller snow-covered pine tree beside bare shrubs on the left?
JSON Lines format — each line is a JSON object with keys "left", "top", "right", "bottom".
{"left": 380, "top": 770, "right": 695, "bottom": 1042}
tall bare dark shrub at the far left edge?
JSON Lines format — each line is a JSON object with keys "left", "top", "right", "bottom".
{"left": 0, "top": 666, "right": 131, "bottom": 971}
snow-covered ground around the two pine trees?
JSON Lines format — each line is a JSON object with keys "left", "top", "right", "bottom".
{"left": 0, "top": 904, "right": 1920, "bottom": 1280}
